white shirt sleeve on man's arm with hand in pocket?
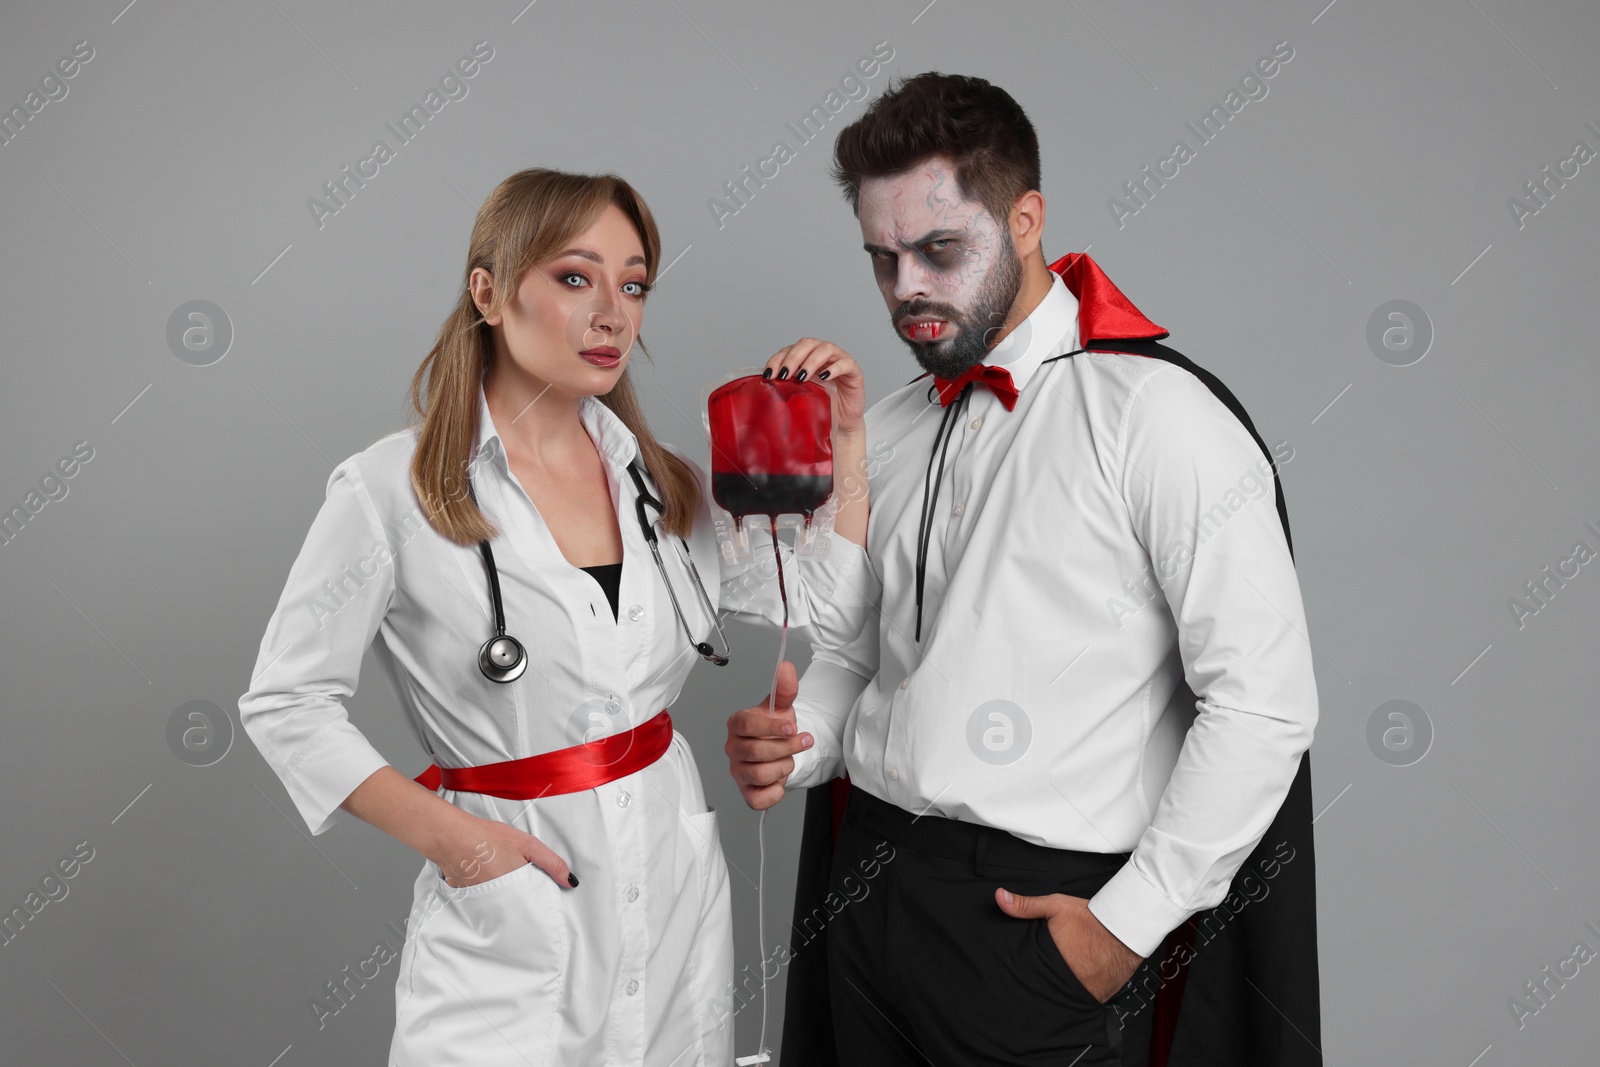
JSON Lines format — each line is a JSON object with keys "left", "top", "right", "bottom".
{"left": 1090, "top": 366, "right": 1317, "bottom": 957}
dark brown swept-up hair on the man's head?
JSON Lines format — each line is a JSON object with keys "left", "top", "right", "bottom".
{"left": 832, "top": 70, "right": 1038, "bottom": 227}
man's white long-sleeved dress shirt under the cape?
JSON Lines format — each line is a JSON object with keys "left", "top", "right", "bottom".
{"left": 789, "top": 277, "right": 1317, "bottom": 955}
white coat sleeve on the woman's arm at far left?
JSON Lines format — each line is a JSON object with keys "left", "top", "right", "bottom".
{"left": 238, "top": 456, "right": 394, "bottom": 835}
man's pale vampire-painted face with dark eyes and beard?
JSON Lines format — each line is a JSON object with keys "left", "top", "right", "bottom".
{"left": 861, "top": 157, "right": 1022, "bottom": 378}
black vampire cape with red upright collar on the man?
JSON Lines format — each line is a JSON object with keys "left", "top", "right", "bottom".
{"left": 779, "top": 253, "right": 1322, "bottom": 1067}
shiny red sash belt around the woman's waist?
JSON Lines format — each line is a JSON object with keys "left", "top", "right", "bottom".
{"left": 414, "top": 709, "right": 672, "bottom": 800}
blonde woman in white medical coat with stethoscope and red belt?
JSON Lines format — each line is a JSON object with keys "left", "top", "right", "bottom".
{"left": 238, "top": 170, "right": 866, "bottom": 1067}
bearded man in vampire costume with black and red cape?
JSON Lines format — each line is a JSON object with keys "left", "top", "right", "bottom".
{"left": 726, "top": 74, "right": 1320, "bottom": 1067}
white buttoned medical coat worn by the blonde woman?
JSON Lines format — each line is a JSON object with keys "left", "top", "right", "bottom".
{"left": 238, "top": 383, "right": 854, "bottom": 1067}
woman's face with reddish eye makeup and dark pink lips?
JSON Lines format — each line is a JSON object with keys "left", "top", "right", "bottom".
{"left": 472, "top": 205, "right": 648, "bottom": 395}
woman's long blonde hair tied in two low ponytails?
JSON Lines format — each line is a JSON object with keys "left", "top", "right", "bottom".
{"left": 411, "top": 166, "right": 701, "bottom": 545}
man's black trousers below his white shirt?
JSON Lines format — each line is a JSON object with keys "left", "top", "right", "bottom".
{"left": 827, "top": 787, "right": 1154, "bottom": 1067}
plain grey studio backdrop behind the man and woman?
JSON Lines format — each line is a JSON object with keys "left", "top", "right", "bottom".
{"left": 0, "top": 0, "right": 1600, "bottom": 1067}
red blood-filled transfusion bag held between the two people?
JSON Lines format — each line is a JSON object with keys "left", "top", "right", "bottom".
{"left": 707, "top": 374, "right": 834, "bottom": 522}
